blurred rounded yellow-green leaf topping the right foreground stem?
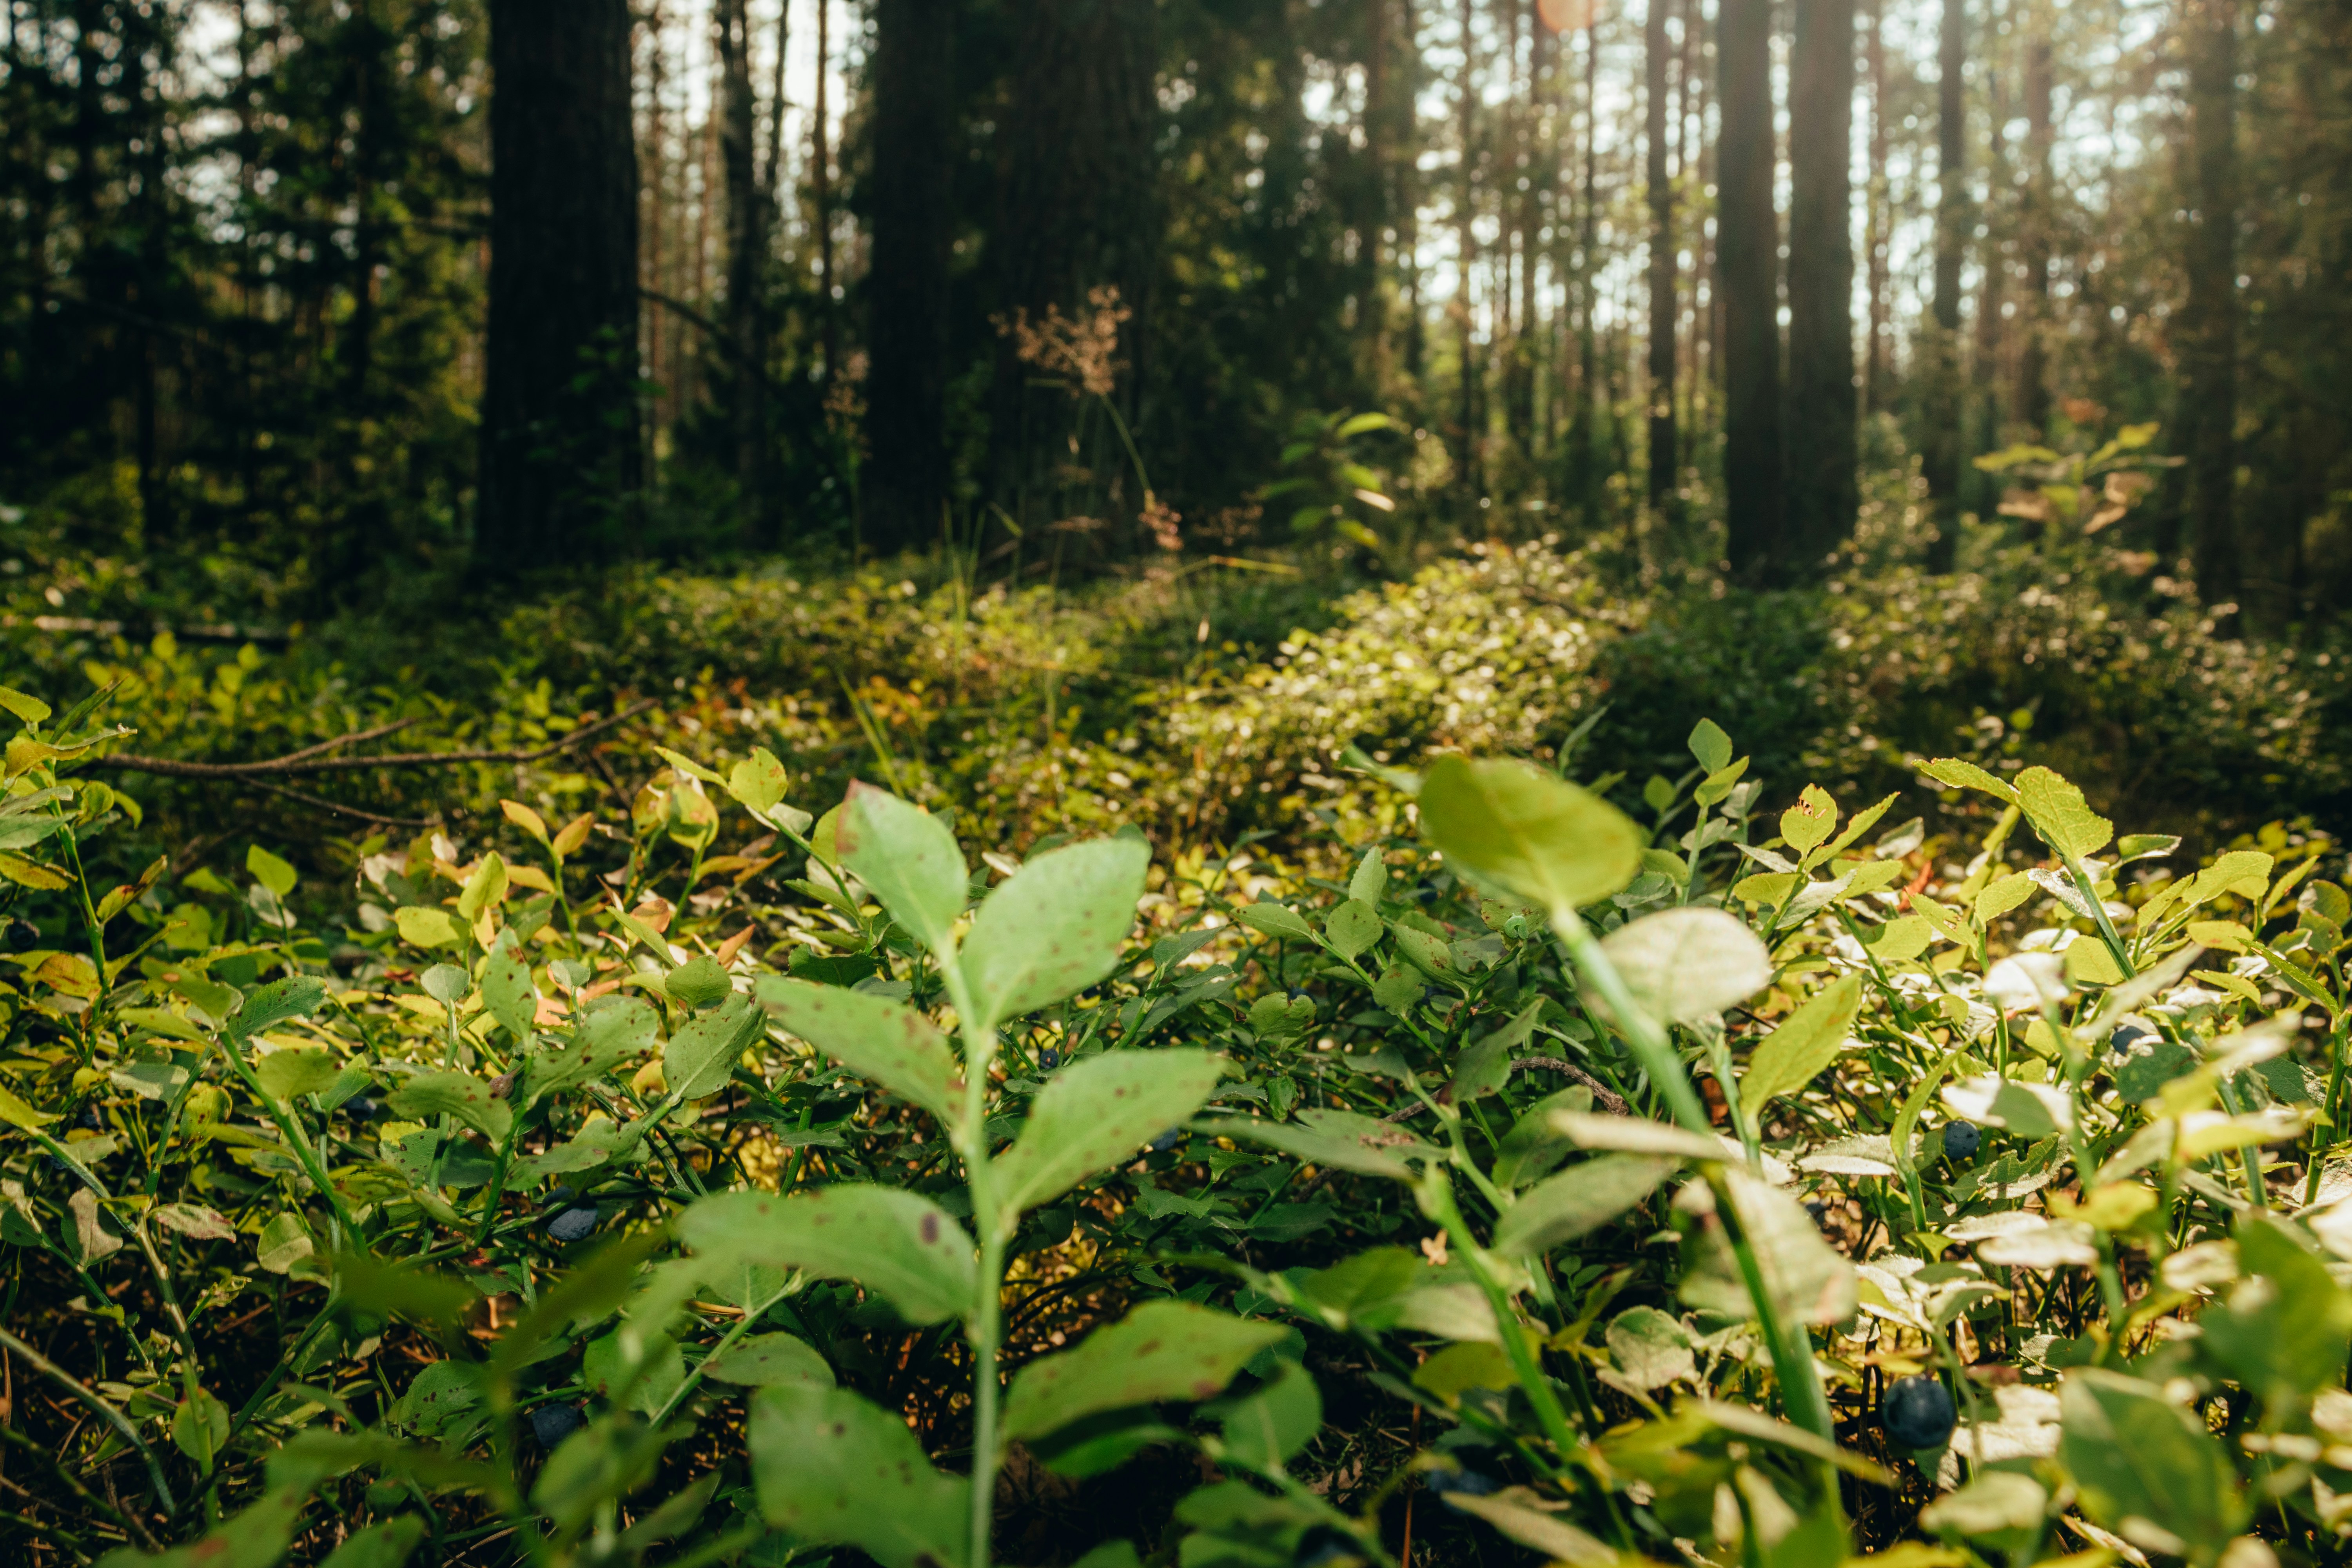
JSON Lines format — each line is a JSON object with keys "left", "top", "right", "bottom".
{"left": 1421, "top": 757, "right": 1642, "bottom": 917}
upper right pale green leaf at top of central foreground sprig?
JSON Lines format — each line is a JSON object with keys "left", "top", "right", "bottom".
{"left": 957, "top": 839, "right": 1152, "bottom": 1034}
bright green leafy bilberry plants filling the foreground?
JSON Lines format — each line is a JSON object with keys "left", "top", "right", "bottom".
{"left": 0, "top": 658, "right": 2352, "bottom": 1568}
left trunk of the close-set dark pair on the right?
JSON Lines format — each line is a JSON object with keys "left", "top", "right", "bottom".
{"left": 1715, "top": 0, "right": 1785, "bottom": 583}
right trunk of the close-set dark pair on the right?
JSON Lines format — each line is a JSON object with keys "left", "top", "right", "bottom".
{"left": 1788, "top": 0, "right": 1860, "bottom": 576}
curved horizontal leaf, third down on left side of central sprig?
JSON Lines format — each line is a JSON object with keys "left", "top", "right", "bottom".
{"left": 677, "top": 1182, "right": 976, "bottom": 1323}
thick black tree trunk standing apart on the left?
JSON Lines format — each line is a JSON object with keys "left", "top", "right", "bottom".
{"left": 475, "top": 0, "right": 642, "bottom": 573}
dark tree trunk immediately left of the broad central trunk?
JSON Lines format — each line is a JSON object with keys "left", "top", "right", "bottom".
{"left": 863, "top": 0, "right": 957, "bottom": 550}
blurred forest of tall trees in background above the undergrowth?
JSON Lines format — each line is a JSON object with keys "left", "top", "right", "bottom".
{"left": 0, "top": 0, "right": 2352, "bottom": 637}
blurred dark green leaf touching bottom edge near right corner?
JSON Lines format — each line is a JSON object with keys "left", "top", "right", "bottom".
{"left": 2058, "top": 1368, "right": 2244, "bottom": 1563}
